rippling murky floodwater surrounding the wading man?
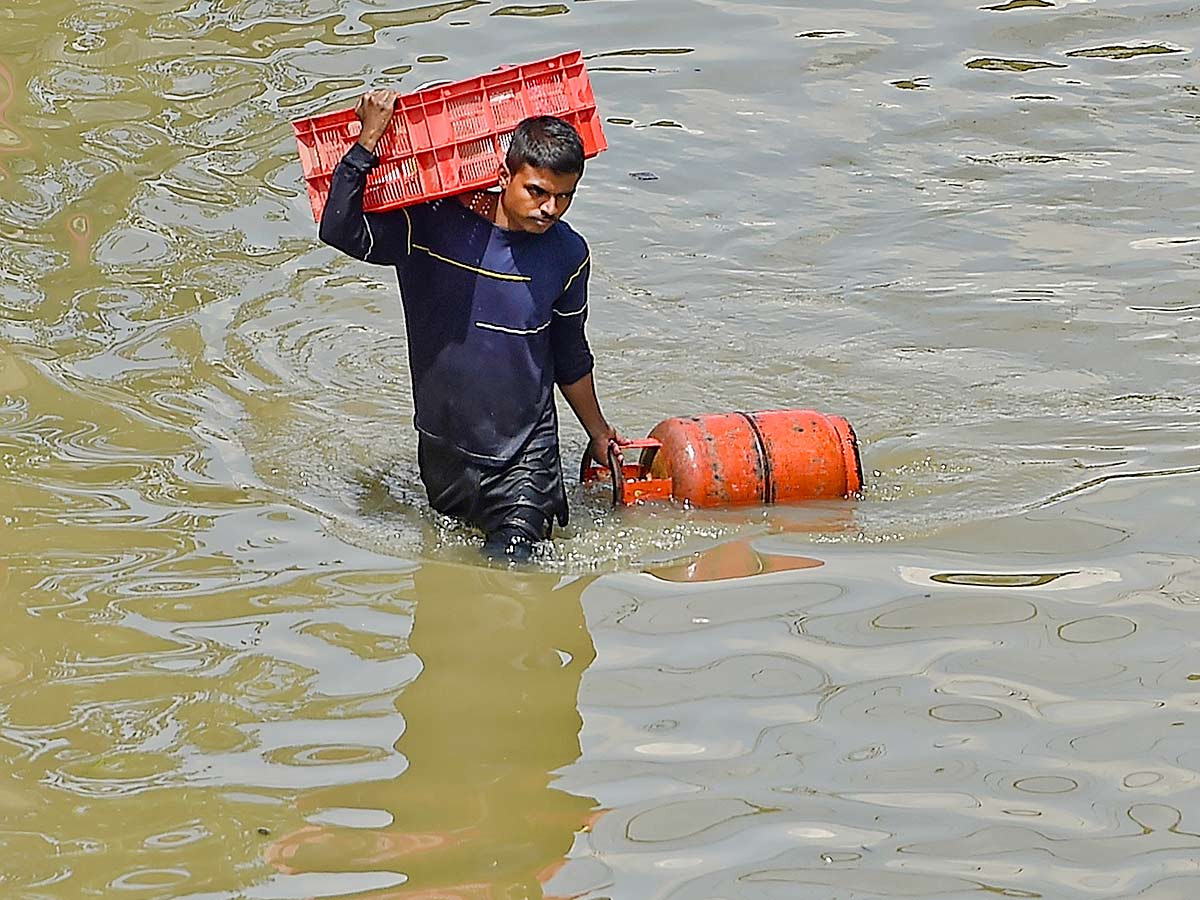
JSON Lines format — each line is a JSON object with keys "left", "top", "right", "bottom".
{"left": 0, "top": 0, "right": 1200, "bottom": 900}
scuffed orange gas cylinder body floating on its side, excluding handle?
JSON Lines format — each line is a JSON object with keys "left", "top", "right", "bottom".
{"left": 649, "top": 409, "right": 863, "bottom": 506}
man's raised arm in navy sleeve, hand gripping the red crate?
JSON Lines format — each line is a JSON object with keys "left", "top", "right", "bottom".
{"left": 320, "top": 91, "right": 413, "bottom": 265}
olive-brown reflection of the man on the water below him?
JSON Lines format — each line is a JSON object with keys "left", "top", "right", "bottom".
{"left": 266, "top": 564, "right": 595, "bottom": 900}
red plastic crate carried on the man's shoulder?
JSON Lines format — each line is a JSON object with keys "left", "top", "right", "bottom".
{"left": 292, "top": 50, "right": 608, "bottom": 222}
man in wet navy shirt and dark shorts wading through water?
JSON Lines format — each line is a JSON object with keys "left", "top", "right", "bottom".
{"left": 320, "top": 90, "right": 622, "bottom": 560}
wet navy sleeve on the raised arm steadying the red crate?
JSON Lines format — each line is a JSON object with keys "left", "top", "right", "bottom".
{"left": 320, "top": 143, "right": 413, "bottom": 265}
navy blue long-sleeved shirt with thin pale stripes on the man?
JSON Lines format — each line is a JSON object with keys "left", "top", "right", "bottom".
{"left": 320, "top": 144, "right": 593, "bottom": 464}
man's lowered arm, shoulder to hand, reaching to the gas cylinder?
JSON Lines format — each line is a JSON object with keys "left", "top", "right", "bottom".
{"left": 550, "top": 257, "right": 624, "bottom": 466}
